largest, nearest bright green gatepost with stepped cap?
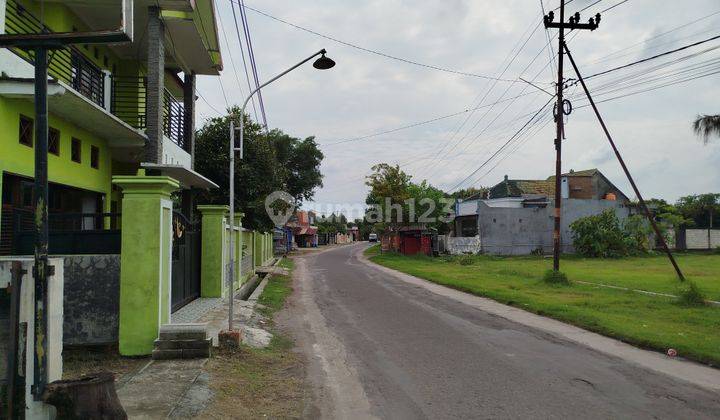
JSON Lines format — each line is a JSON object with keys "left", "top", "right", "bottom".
{"left": 112, "top": 170, "right": 179, "bottom": 356}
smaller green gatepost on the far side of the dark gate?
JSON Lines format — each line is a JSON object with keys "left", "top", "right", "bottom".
{"left": 197, "top": 205, "right": 230, "bottom": 297}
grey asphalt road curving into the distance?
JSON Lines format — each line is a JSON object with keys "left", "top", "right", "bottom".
{"left": 284, "top": 244, "right": 720, "bottom": 419}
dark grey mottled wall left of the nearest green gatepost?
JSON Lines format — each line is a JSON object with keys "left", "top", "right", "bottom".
{"left": 63, "top": 255, "right": 120, "bottom": 345}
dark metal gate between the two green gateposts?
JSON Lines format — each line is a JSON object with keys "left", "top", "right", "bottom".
{"left": 171, "top": 211, "right": 202, "bottom": 312}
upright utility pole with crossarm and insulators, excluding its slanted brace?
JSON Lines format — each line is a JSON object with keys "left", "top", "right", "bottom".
{"left": 543, "top": 0, "right": 600, "bottom": 272}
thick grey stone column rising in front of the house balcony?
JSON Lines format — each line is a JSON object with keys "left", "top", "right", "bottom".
{"left": 145, "top": 6, "right": 165, "bottom": 163}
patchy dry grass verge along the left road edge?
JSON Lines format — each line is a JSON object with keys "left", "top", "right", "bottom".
{"left": 202, "top": 258, "right": 306, "bottom": 419}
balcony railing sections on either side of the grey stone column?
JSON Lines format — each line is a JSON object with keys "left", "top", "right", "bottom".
{"left": 110, "top": 76, "right": 185, "bottom": 149}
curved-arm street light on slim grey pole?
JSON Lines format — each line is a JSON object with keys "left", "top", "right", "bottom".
{"left": 227, "top": 48, "right": 335, "bottom": 331}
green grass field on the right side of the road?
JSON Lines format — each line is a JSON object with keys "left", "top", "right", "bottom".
{"left": 366, "top": 247, "right": 720, "bottom": 366}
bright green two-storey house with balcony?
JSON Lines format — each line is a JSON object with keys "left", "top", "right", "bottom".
{"left": 0, "top": 0, "right": 222, "bottom": 255}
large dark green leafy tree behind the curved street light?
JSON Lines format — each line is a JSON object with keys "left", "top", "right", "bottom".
{"left": 195, "top": 107, "right": 323, "bottom": 231}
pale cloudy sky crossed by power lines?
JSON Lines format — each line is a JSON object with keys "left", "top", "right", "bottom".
{"left": 198, "top": 0, "right": 720, "bottom": 217}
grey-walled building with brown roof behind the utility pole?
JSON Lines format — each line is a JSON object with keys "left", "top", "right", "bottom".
{"left": 456, "top": 169, "right": 630, "bottom": 255}
